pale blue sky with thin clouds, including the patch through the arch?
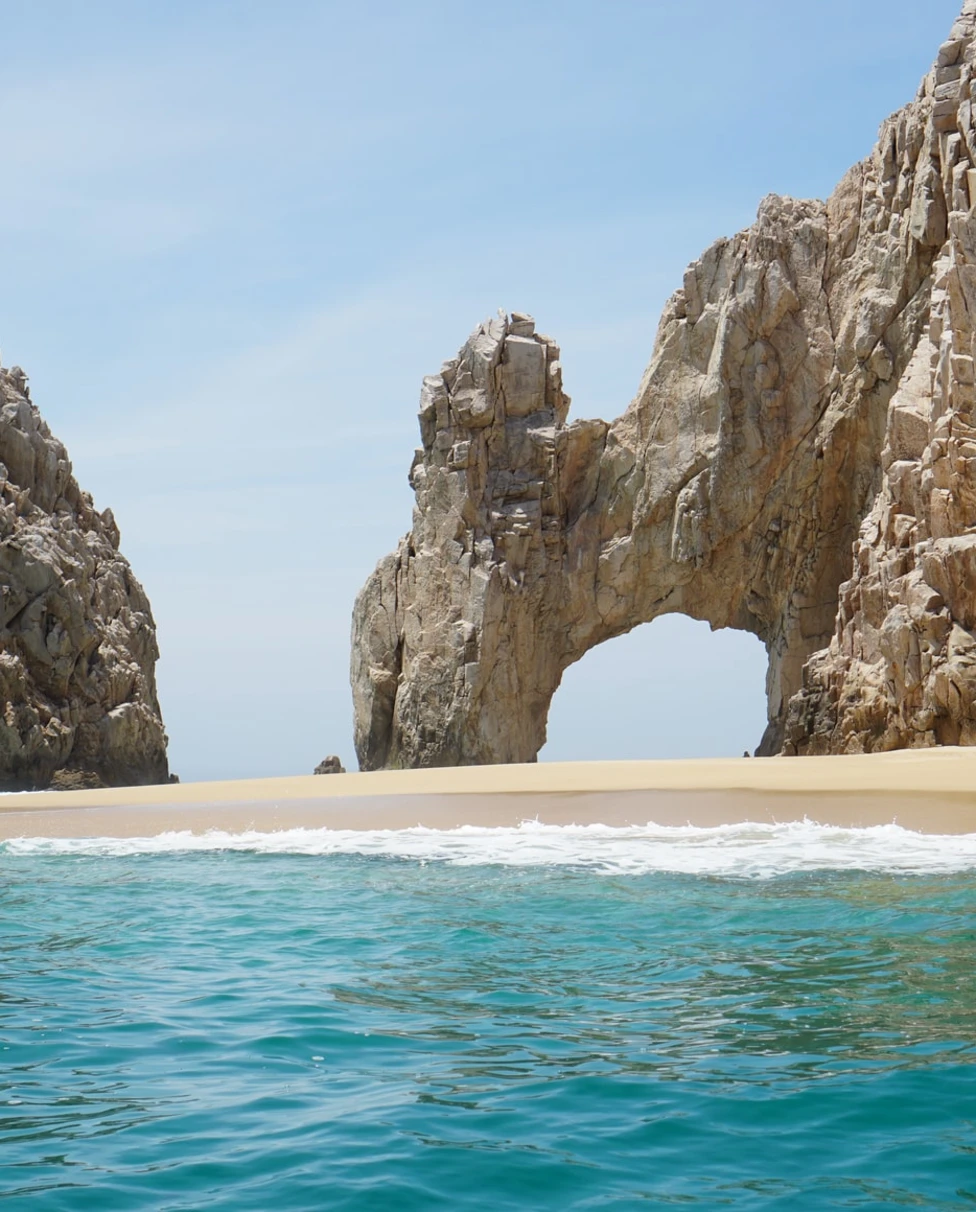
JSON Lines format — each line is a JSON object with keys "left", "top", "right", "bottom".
{"left": 0, "top": 0, "right": 960, "bottom": 779}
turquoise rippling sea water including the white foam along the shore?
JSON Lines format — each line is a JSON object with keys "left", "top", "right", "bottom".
{"left": 0, "top": 824, "right": 976, "bottom": 1212}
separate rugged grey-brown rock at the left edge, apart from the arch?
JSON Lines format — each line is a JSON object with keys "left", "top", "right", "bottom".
{"left": 0, "top": 367, "right": 167, "bottom": 790}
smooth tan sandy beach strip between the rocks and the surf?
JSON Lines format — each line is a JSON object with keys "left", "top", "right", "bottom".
{"left": 0, "top": 749, "right": 976, "bottom": 839}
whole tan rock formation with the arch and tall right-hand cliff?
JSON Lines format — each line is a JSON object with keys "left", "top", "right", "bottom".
{"left": 352, "top": 0, "right": 976, "bottom": 768}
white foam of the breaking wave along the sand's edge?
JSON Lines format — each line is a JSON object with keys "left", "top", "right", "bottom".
{"left": 0, "top": 821, "right": 976, "bottom": 879}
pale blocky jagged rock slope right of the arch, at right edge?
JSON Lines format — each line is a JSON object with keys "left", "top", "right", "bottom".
{"left": 784, "top": 211, "right": 976, "bottom": 753}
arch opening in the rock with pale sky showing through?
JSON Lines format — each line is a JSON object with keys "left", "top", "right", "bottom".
{"left": 538, "top": 614, "right": 767, "bottom": 761}
